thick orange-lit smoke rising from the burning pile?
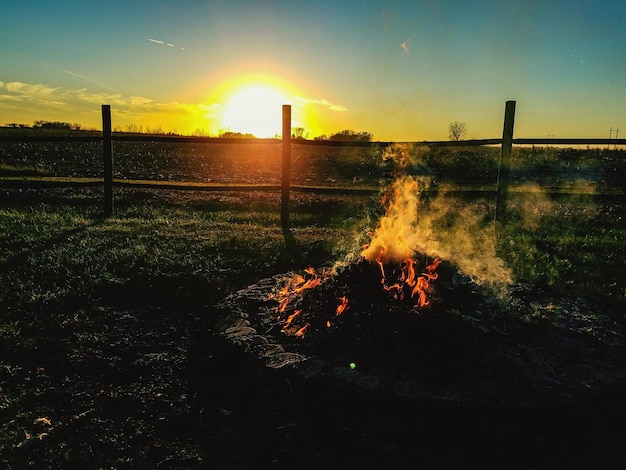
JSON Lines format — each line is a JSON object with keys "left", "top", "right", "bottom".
{"left": 361, "top": 144, "right": 512, "bottom": 292}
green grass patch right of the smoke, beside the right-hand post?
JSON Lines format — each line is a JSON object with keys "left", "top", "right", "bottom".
{"left": 494, "top": 202, "right": 626, "bottom": 301}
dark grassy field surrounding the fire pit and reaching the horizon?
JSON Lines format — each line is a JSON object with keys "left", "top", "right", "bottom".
{"left": 0, "top": 143, "right": 626, "bottom": 468}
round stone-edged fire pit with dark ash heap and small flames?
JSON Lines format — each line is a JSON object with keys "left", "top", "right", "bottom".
{"left": 213, "top": 253, "right": 626, "bottom": 404}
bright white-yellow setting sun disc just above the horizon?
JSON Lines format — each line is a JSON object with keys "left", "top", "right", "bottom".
{"left": 221, "top": 85, "right": 289, "bottom": 137}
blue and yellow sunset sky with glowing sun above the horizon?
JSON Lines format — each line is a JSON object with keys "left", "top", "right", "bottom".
{"left": 0, "top": 0, "right": 626, "bottom": 141}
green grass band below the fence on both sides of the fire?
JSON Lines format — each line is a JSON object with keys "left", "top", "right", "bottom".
{"left": 0, "top": 185, "right": 626, "bottom": 330}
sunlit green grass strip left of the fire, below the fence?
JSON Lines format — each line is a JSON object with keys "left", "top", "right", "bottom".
{"left": 0, "top": 190, "right": 358, "bottom": 321}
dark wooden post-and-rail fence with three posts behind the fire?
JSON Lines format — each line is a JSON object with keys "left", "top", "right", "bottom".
{"left": 0, "top": 101, "right": 626, "bottom": 230}
